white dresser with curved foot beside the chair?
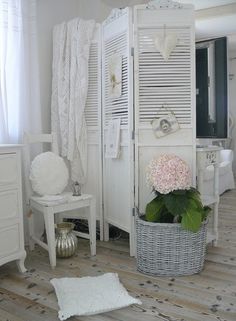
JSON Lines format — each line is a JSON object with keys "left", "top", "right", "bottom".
{"left": 0, "top": 145, "right": 26, "bottom": 272}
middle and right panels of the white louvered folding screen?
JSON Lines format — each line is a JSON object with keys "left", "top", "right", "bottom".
{"left": 102, "top": 0, "right": 196, "bottom": 255}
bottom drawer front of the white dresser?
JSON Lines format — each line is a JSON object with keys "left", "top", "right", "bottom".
{"left": 0, "top": 224, "right": 20, "bottom": 257}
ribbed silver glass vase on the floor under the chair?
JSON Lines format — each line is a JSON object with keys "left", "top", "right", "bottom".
{"left": 56, "top": 222, "right": 78, "bottom": 258}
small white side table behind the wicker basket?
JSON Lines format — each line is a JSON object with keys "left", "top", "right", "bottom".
{"left": 197, "top": 146, "right": 222, "bottom": 246}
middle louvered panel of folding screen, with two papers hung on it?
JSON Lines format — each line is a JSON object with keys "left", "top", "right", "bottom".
{"left": 102, "top": 8, "right": 134, "bottom": 252}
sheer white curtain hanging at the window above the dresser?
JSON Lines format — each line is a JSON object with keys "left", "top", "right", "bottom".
{"left": 0, "top": 0, "right": 41, "bottom": 143}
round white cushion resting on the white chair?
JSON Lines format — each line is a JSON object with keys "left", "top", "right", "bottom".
{"left": 30, "top": 152, "right": 69, "bottom": 195}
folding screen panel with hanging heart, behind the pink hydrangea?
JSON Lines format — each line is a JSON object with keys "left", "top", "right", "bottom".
{"left": 134, "top": 0, "right": 196, "bottom": 211}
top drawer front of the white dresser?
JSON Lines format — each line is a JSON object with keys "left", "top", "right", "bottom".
{"left": 0, "top": 154, "right": 18, "bottom": 186}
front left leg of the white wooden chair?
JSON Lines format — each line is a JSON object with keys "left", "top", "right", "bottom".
{"left": 43, "top": 208, "right": 56, "bottom": 268}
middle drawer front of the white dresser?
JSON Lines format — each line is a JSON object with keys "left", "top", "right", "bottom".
{"left": 0, "top": 190, "right": 19, "bottom": 220}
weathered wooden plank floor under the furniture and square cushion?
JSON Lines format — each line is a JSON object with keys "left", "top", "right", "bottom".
{"left": 0, "top": 190, "right": 236, "bottom": 321}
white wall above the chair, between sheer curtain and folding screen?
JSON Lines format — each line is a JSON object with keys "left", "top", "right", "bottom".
{"left": 37, "top": 0, "right": 110, "bottom": 133}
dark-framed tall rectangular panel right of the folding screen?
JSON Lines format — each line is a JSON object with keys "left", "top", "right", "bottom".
{"left": 196, "top": 37, "right": 228, "bottom": 138}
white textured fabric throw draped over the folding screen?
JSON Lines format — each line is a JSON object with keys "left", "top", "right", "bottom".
{"left": 51, "top": 18, "right": 95, "bottom": 184}
